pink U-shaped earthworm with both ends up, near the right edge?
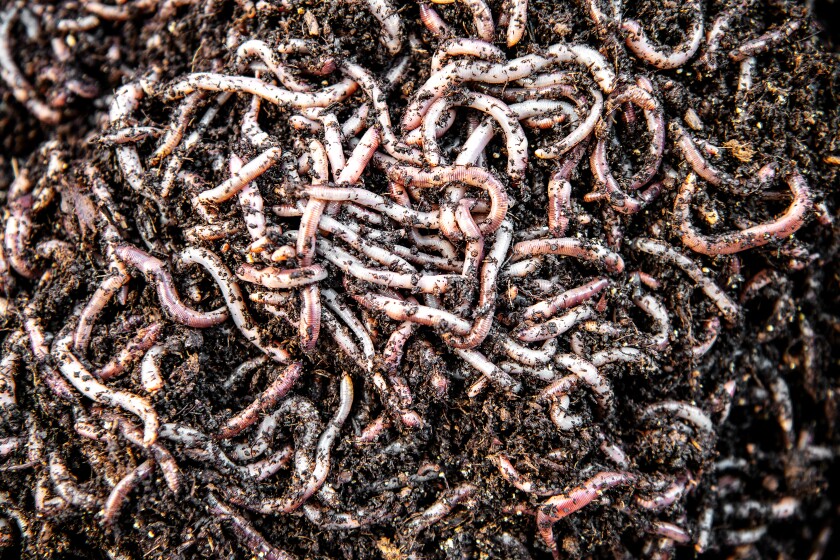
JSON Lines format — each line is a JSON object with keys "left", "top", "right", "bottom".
{"left": 674, "top": 171, "right": 813, "bottom": 255}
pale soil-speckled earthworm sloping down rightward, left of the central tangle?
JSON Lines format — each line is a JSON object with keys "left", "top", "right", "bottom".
{"left": 178, "top": 247, "right": 291, "bottom": 364}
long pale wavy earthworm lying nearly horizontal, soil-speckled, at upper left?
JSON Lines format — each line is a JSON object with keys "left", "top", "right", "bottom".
{"left": 163, "top": 72, "right": 358, "bottom": 109}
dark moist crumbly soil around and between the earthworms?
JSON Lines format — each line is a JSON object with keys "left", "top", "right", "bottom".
{"left": 0, "top": 0, "right": 840, "bottom": 560}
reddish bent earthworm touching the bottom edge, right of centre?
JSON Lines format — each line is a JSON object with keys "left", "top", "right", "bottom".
{"left": 537, "top": 471, "right": 636, "bottom": 560}
